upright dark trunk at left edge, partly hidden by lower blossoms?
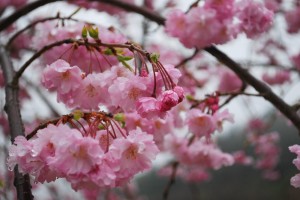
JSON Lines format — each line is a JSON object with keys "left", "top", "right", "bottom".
{"left": 0, "top": 46, "right": 33, "bottom": 200}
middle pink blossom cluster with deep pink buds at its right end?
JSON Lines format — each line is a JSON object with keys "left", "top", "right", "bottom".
{"left": 42, "top": 60, "right": 184, "bottom": 113}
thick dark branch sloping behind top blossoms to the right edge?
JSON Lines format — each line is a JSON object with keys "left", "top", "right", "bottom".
{"left": 98, "top": 0, "right": 300, "bottom": 134}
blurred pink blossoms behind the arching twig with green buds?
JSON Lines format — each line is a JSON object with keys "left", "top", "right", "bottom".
{"left": 31, "top": 22, "right": 132, "bottom": 73}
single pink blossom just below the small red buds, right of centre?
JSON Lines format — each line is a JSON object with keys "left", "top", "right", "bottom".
{"left": 186, "top": 109, "right": 216, "bottom": 138}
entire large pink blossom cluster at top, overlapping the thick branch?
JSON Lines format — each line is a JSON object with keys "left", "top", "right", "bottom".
{"left": 166, "top": 0, "right": 273, "bottom": 48}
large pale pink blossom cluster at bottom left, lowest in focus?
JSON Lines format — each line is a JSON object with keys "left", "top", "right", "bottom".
{"left": 8, "top": 124, "right": 159, "bottom": 190}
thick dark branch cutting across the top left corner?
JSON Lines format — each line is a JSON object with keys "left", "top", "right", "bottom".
{"left": 0, "top": 0, "right": 62, "bottom": 32}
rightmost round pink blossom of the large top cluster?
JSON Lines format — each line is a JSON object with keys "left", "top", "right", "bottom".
{"left": 237, "top": 0, "right": 274, "bottom": 38}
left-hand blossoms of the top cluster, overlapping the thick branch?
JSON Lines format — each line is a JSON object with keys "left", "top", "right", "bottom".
{"left": 166, "top": 7, "right": 234, "bottom": 48}
